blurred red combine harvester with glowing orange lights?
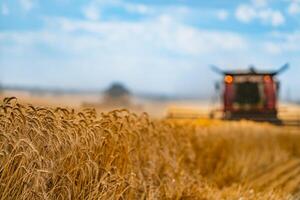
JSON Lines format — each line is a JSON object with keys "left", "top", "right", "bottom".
{"left": 212, "top": 64, "right": 289, "bottom": 123}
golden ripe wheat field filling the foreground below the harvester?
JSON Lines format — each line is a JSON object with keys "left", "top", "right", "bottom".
{"left": 0, "top": 98, "right": 300, "bottom": 200}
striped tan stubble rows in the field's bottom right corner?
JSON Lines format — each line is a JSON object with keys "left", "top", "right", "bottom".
{"left": 247, "top": 159, "right": 300, "bottom": 199}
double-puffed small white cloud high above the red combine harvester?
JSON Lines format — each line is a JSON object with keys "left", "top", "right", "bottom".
{"left": 235, "top": 4, "right": 285, "bottom": 27}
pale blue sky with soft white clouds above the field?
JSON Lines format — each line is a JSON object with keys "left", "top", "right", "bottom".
{"left": 0, "top": 0, "right": 300, "bottom": 99}
